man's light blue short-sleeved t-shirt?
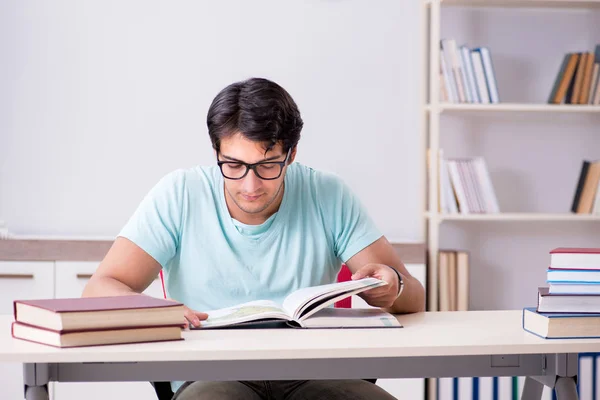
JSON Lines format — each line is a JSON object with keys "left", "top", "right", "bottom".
{"left": 119, "top": 163, "right": 382, "bottom": 391}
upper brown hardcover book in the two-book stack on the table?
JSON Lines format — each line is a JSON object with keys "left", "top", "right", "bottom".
{"left": 13, "top": 295, "right": 185, "bottom": 331}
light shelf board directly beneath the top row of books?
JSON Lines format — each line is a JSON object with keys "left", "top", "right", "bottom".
{"left": 425, "top": 103, "right": 600, "bottom": 113}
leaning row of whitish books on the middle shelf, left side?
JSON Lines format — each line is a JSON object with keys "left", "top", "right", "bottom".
{"left": 438, "top": 149, "right": 500, "bottom": 214}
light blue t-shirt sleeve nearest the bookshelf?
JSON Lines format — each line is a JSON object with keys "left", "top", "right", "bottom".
{"left": 317, "top": 173, "right": 382, "bottom": 262}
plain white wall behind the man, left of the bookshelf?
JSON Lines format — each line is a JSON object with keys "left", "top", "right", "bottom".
{"left": 0, "top": 0, "right": 423, "bottom": 240}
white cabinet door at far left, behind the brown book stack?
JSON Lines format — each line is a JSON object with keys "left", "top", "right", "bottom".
{"left": 0, "top": 261, "right": 54, "bottom": 400}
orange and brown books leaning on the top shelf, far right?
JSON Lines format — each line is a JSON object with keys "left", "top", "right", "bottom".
{"left": 548, "top": 44, "right": 600, "bottom": 105}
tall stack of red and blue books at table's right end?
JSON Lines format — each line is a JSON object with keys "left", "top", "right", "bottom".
{"left": 523, "top": 247, "right": 600, "bottom": 338}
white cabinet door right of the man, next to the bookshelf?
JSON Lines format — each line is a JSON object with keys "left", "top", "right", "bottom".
{"left": 352, "top": 264, "right": 427, "bottom": 399}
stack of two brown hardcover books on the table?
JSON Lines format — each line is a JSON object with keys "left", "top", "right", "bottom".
{"left": 11, "top": 295, "right": 184, "bottom": 347}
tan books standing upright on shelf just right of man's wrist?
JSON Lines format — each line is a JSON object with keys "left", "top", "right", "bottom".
{"left": 437, "top": 250, "right": 470, "bottom": 311}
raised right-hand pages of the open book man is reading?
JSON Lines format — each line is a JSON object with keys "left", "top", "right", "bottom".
{"left": 283, "top": 278, "right": 387, "bottom": 320}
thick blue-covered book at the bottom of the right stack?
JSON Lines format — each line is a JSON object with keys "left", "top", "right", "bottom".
{"left": 522, "top": 307, "right": 600, "bottom": 339}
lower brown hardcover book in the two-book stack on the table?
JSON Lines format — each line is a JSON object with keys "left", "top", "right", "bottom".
{"left": 11, "top": 322, "right": 182, "bottom": 347}
